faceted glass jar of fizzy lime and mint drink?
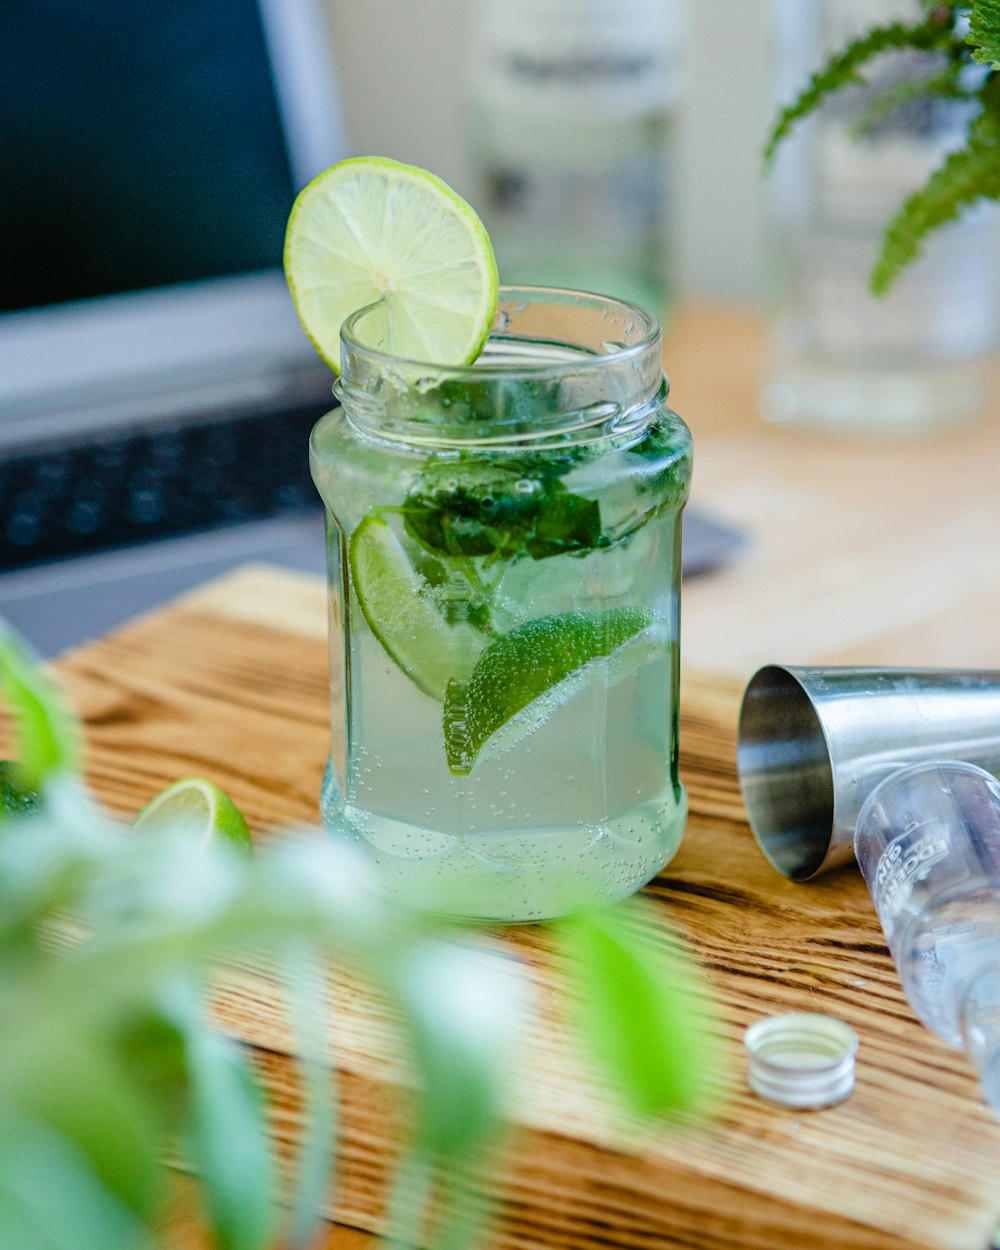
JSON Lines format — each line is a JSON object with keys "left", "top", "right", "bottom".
{"left": 311, "top": 288, "right": 691, "bottom": 921}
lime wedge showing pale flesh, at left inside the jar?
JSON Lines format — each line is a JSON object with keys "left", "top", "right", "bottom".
{"left": 348, "top": 516, "right": 486, "bottom": 703}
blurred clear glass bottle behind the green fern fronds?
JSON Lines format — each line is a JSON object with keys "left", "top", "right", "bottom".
{"left": 760, "top": 0, "right": 1000, "bottom": 435}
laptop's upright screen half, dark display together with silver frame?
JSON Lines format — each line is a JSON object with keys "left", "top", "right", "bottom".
{"left": 0, "top": 0, "right": 346, "bottom": 440}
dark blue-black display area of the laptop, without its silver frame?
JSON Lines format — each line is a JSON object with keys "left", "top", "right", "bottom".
{"left": 0, "top": 0, "right": 301, "bottom": 311}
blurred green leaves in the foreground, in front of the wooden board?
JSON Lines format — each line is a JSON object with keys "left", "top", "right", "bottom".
{"left": 0, "top": 624, "right": 715, "bottom": 1250}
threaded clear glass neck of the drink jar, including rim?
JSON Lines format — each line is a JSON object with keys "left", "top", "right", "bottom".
{"left": 334, "top": 288, "right": 668, "bottom": 450}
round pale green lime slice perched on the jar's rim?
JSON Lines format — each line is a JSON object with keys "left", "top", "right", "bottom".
{"left": 285, "top": 156, "right": 499, "bottom": 371}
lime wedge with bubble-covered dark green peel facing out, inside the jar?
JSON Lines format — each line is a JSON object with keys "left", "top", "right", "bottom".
{"left": 444, "top": 608, "right": 663, "bottom": 775}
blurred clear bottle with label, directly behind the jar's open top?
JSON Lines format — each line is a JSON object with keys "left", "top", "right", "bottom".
{"left": 470, "top": 0, "right": 683, "bottom": 319}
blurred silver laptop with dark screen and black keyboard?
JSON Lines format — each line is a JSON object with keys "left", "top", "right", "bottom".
{"left": 0, "top": 0, "right": 346, "bottom": 654}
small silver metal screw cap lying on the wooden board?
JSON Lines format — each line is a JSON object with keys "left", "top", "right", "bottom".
{"left": 744, "top": 1011, "right": 859, "bottom": 1110}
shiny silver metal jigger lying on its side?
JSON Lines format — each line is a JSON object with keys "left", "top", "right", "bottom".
{"left": 736, "top": 664, "right": 1000, "bottom": 881}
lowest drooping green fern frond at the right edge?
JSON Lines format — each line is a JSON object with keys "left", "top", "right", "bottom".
{"left": 871, "top": 79, "right": 1000, "bottom": 295}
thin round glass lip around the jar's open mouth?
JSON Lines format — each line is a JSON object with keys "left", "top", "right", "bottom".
{"left": 340, "top": 284, "right": 663, "bottom": 379}
